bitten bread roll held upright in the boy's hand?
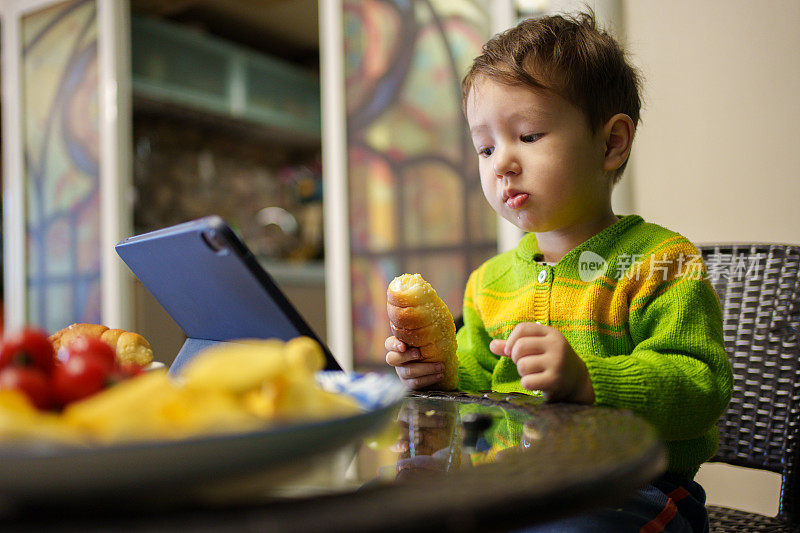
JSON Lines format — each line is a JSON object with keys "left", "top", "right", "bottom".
{"left": 386, "top": 274, "right": 458, "bottom": 390}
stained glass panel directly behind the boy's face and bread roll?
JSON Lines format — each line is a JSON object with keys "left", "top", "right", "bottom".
{"left": 344, "top": 0, "right": 497, "bottom": 367}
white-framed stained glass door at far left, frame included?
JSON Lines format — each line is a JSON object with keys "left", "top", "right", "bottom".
{"left": 0, "top": 0, "right": 130, "bottom": 331}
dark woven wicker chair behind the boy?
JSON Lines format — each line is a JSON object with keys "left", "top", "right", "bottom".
{"left": 699, "top": 244, "right": 800, "bottom": 532}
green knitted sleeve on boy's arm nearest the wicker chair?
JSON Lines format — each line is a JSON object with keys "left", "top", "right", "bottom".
{"left": 584, "top": 247, "right": 733, "bottom": 440}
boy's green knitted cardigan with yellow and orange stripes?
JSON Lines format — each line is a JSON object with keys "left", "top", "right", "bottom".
{"left": 458, "top": 215, "right": 732, "bottom": 478}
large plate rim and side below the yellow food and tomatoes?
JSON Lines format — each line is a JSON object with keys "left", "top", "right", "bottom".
{"left": 0, "top": 372, "right": 406, "bottom": 503}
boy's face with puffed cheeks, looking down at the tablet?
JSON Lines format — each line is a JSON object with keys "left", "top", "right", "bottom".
{"left": 466, "top": 77, "right": 611, "bottom": 233}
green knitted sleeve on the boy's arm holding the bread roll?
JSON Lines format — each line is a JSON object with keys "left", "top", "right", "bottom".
{"left": 456, "top": 271, "right": 498, "bottom": 391}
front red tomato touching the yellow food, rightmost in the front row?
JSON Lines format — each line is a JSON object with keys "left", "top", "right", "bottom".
{"left": 51, "top": 352, "right": 111, "bottom": 405}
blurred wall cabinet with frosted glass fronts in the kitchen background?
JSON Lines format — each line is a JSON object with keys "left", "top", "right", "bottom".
{"left": 131, "top": 15, "right": 320, "bottom": 143}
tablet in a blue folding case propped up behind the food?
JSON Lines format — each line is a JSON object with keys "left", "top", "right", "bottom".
{"left": 115, "top": 216, "right": 341, "bottom": 372}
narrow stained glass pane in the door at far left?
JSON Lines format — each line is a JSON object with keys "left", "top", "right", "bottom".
{"left": 21, "top": 0, "right": 101, "bottom": 331}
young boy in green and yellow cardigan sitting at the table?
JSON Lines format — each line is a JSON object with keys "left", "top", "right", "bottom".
{"left": 386, "top": 10, "right": 732, "bottom": 531}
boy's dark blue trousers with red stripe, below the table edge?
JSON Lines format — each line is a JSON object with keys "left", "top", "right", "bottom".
{"left": 520, "top": 474, "right": 709, "bottom": 533}
